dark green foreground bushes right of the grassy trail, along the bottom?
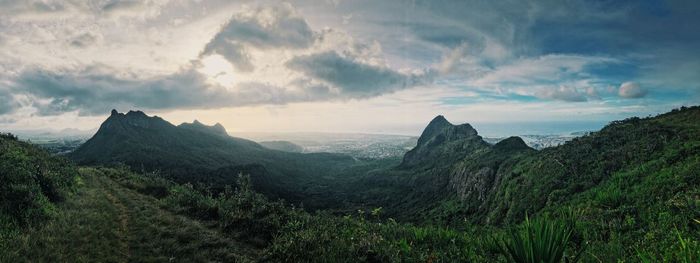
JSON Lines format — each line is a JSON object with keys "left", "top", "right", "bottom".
{"left": 93, "top": 168, "right": 698, "bottom": 262}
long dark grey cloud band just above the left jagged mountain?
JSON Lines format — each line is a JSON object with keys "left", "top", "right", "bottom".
{"left": 14, "top": 68, "right": 243, "bottom": 115}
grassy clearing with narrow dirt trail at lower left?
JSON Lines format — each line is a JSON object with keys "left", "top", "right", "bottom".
{"left": 0, "top": 168, "right": 259, "bottom": 262}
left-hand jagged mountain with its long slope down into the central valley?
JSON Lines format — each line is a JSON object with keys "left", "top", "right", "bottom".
{"left": 68, "top": 110, "right": 378, "bottom": 206}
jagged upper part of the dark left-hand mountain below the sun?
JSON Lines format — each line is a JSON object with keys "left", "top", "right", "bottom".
{"left": 70, "top": 110, "right": 265, "bottom": 168}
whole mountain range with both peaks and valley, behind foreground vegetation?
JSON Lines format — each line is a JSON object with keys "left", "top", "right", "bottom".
{"left": 70, "top": 107, "right": 700, "bottom": 229}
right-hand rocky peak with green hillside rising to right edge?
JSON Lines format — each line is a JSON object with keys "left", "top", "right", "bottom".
{"left": 374, "top": 107, "right": 700, "bottom": 231}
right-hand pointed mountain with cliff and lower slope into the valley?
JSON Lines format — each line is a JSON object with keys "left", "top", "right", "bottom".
{"left": 354, "top": 116, "right": 536, "bottom": 222}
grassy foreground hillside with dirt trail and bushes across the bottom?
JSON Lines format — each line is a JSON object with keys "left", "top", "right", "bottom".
{"left": 49, "top": 168, "right": 700, "bottom": 262}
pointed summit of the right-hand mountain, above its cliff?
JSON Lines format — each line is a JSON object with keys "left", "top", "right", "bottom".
{"left": 401, "top": 115, "right": 489, "bottom": 168}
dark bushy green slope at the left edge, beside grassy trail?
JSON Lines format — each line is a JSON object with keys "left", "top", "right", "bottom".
{"left": 0, "top": 134, "right": 80, "bottom": 256}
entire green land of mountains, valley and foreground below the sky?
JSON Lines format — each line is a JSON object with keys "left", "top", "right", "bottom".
{"left": 0, "top": 107, "right": 700, "bottom": 262}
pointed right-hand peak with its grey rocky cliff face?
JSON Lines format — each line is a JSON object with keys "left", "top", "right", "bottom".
{"left": 399, "top": 116, "right": 535, "bottom": 221}
